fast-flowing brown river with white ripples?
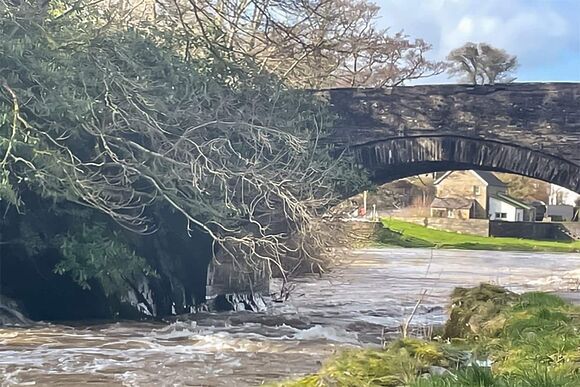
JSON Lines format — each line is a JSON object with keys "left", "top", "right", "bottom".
{"left": 0, "top": 249, "right": 580, "bottom": 386}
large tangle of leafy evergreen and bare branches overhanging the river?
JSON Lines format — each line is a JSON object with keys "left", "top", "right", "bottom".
{"left": 0, "top": 0, "right": 445, "bottom": 319}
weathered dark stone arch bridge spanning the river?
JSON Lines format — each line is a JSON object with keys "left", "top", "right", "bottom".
{"left": 317, "top": 83, "right": 580, "bottom": 192}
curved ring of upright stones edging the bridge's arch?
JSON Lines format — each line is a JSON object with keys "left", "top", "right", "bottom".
{"left": 350, "top": 135, "right": 580, "bottom": 193}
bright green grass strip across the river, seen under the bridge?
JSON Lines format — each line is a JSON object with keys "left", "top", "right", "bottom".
{"left": 378, "top": 219, "right": 580, "bottom": 252}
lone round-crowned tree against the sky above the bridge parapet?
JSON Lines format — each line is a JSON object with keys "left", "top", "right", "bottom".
{"left": 447, "top": 42, "right": 518, "bottom": 85}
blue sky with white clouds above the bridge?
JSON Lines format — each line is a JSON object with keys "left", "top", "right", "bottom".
{"left": 374, "top": 0, "right": 580, "bottom": 83}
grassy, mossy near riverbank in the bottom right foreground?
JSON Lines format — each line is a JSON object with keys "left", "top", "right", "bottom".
{"left": 279, "top": 284, "right": 580, "bottom": 387}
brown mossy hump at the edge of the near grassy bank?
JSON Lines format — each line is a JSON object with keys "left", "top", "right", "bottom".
{"left": 443, "top": 284, "right": 520, "bottom": 338}
